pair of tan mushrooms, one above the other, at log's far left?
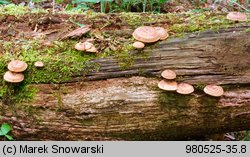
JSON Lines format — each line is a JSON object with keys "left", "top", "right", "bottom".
{"left": 3, "top": 60, "right": 28, "bottom": 83}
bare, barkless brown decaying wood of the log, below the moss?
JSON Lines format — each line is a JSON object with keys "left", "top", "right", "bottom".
{"left": 1, "top": 27, "right": 250, "bottom": 140}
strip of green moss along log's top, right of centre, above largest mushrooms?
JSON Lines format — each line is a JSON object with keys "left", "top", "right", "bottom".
{"left": 120, "top": 11, "right": 250, "bottom": 37}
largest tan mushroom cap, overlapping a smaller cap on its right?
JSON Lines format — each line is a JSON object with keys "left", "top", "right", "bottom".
{"left": 132, "top": 26, "right": 160, "bottom": 43}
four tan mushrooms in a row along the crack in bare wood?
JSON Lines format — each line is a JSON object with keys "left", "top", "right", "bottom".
{"left": 158, "top": 70, "right": 224, "bottom": 97}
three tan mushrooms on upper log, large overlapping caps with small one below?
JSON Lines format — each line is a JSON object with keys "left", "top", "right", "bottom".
{"left": 132, "top": 26, "right": 169, "bottom": 49}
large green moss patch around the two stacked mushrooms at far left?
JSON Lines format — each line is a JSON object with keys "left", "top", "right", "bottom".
{"left": 0, "top": 41, "right": 99, "bottom": 104}
